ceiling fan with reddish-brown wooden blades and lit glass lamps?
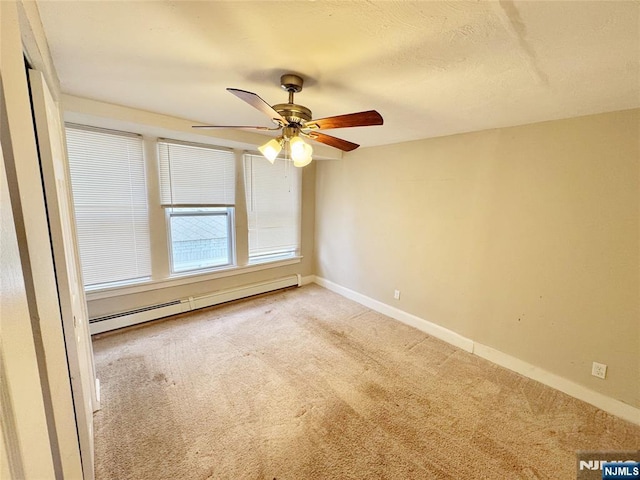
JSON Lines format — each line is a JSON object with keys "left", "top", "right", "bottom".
{"left": 193, "top": 73, "right": 383, "bottom": 167}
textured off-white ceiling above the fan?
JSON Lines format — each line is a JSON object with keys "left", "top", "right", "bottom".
{"left": 38, "top": 0, "right": 640, "bottom": 146}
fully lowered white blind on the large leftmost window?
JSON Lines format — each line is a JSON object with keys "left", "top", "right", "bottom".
{"left": 66, "top": 125, "right": 151, "bottom": 286}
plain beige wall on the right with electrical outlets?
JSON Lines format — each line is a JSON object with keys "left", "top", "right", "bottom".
{"left": 316, "top": 110, "right": 640, "bottom": 407}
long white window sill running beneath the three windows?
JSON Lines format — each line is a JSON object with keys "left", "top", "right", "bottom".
{"left": 86, "top": 256, "right": 302, "bottom": 301}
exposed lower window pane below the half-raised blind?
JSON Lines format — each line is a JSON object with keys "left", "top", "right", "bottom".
{"left": 169, "top": 209, "right": 231, "bottom": 272}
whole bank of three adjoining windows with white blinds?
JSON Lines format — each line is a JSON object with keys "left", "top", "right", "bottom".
{"left": 66, "top": 124, "right": 302, "bottom": 295}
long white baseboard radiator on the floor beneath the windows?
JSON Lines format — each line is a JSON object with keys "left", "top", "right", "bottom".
{"left": 89, "top": 274, "right": 302, "bottom": 335}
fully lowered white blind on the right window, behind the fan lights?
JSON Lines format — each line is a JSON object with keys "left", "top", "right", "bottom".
{"left": 244, "top": 155, "right": 302, "bottom": 261}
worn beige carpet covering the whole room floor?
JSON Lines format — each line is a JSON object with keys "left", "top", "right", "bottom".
{"left": 94, "top": 285, "right": 640, "bottom": 480}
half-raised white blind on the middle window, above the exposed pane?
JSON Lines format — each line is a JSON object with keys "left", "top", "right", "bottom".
{"left": 158, "top": 141, "right": 236, "bottom": 207}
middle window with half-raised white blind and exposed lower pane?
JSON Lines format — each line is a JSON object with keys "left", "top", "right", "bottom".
{"left": 158, "top": 140, "right": 235, "bottom": 273}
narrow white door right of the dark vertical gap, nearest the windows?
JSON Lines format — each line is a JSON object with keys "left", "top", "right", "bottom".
{"left": 29, "top": 70, "right": 98, "bottom": 480}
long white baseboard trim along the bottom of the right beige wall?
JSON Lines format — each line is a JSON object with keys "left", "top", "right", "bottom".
{"left": 312, "top": 276, "right": 640, "bottom": 425}
